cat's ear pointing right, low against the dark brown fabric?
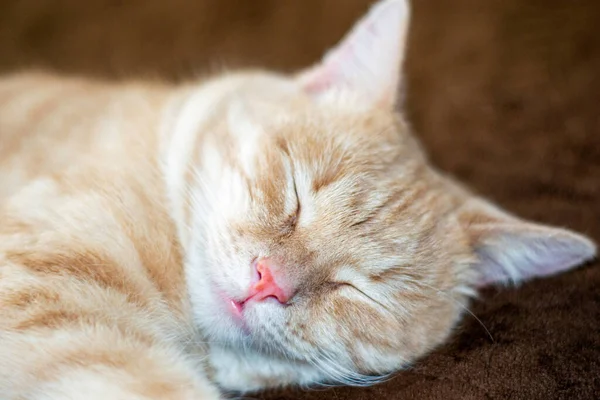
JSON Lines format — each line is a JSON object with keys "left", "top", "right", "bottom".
{"left": 458, "top": 198, "right": 596, "bottom": 286}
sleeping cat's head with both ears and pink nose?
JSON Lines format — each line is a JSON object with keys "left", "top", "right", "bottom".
{"left": 168, "top": 0, "right": 595, "bottom": 389}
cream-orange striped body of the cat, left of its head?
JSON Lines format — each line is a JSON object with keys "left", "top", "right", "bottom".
{"left": 0, "top": 74, "right": 216, "bottom": 399}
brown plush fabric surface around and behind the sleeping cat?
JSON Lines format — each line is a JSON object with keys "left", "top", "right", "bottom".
{"left": 0, "top": 0, "right": 600, "bottom": 400}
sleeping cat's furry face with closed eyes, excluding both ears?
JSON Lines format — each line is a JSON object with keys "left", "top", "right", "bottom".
{"left": 185, "top": 77, "right": 471, "bottom": 379}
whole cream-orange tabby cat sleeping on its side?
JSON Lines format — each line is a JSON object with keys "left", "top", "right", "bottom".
{"left": 0, "top": 0, "right": 595, "bottom": 400}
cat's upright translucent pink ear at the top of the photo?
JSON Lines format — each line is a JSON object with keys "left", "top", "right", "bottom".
{"left": 297, "top": 0, "right": 410, "bottom": 108}
